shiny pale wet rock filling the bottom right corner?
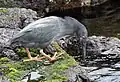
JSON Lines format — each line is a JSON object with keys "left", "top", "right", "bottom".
{"left": 88, "top": 67, "right": 120, "bottom": 82}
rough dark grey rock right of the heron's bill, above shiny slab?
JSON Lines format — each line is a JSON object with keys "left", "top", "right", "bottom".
{"left": 87, "top": 36, "right": 120, "bottom": 65}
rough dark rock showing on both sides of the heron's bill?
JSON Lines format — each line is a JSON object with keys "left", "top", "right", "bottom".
{"left": 59, "top": 36, "right": 120, "bottom": 66}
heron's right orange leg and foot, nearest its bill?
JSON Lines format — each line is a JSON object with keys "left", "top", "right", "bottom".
{"left": 40, "top": 49, "right": 62, "bottom": 62}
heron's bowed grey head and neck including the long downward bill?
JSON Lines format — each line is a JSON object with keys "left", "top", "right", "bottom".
{"left": 65, "top": 17, "right": 88, "bottom": 60}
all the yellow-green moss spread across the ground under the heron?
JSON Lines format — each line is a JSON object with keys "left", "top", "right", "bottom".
{"left": 0, "top": 42, "right": 77, "bottom": 82}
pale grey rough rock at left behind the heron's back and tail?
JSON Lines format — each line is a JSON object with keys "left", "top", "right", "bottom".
{"left": 0, "top": 8, "right": 37, "bottom": 59}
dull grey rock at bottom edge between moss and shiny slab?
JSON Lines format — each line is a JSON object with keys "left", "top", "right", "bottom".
{"left": 65, "top": 65, "right": 90, "bottom": 82}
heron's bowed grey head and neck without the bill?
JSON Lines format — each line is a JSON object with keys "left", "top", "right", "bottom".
{"left": 65, "top": 16, "right": 88, "bottom": 39}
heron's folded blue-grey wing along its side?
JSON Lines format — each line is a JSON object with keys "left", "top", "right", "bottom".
{"left": 11, "top": 21, "right": 60, "bottom": 43}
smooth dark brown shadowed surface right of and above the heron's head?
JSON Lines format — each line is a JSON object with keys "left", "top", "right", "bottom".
{"left": 83, "top": 0, "right": 120, "bottom": 37}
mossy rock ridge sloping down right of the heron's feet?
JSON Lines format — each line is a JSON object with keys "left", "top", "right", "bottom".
{"left": 39, "top": 42, "right": 77, "bottom": 82}
